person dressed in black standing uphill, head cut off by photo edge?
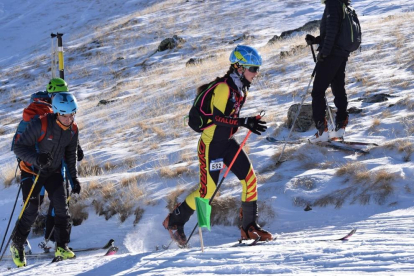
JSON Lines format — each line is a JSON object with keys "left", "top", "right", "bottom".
{"left": 305, "top": 0, "right": 350, "bottom": 143}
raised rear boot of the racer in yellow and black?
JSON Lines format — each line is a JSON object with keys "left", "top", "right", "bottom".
{"left": 162, "top": 201, "right": 194, "bottom": 246}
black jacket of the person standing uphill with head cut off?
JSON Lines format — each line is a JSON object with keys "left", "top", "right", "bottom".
{"left": 319, "top": 0, "right": 351, "bottom": 57}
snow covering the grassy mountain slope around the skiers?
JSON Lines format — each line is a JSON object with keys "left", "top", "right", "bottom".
{"left": 0, "top": 0, "right": 414, "bottom": 275}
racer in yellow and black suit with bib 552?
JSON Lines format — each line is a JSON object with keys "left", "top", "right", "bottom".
{"left": 162, "top": 45, "right": 272, "bottom": 245}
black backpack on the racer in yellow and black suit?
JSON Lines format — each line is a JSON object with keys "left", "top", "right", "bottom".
{"left": 188, "top": 80, "right": 225, "bottom": 133}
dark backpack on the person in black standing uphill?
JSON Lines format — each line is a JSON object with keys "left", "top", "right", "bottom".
{"left": 337, "top": 0, "right": 362, "bottom": 52}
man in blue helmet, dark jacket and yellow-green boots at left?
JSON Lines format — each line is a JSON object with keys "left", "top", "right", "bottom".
{"left": 10, "top": 92, "right": 81, "bottom": 267}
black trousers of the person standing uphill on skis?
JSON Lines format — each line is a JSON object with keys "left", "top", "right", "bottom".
{"left": 312, "top": 56, "right": 348, "bottom": 125}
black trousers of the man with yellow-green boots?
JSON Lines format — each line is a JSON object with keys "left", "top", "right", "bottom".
{"left": 13, "top": 170, "right": 70, "bottom": 245}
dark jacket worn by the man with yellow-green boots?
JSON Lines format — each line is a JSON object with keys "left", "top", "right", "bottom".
{"left": 14, "top": 113, "right": 79, "bottom": 178}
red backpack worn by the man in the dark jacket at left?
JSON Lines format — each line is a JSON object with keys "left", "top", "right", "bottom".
{"left": 11, "top": 101, "right": 53, "bottom": 151}
